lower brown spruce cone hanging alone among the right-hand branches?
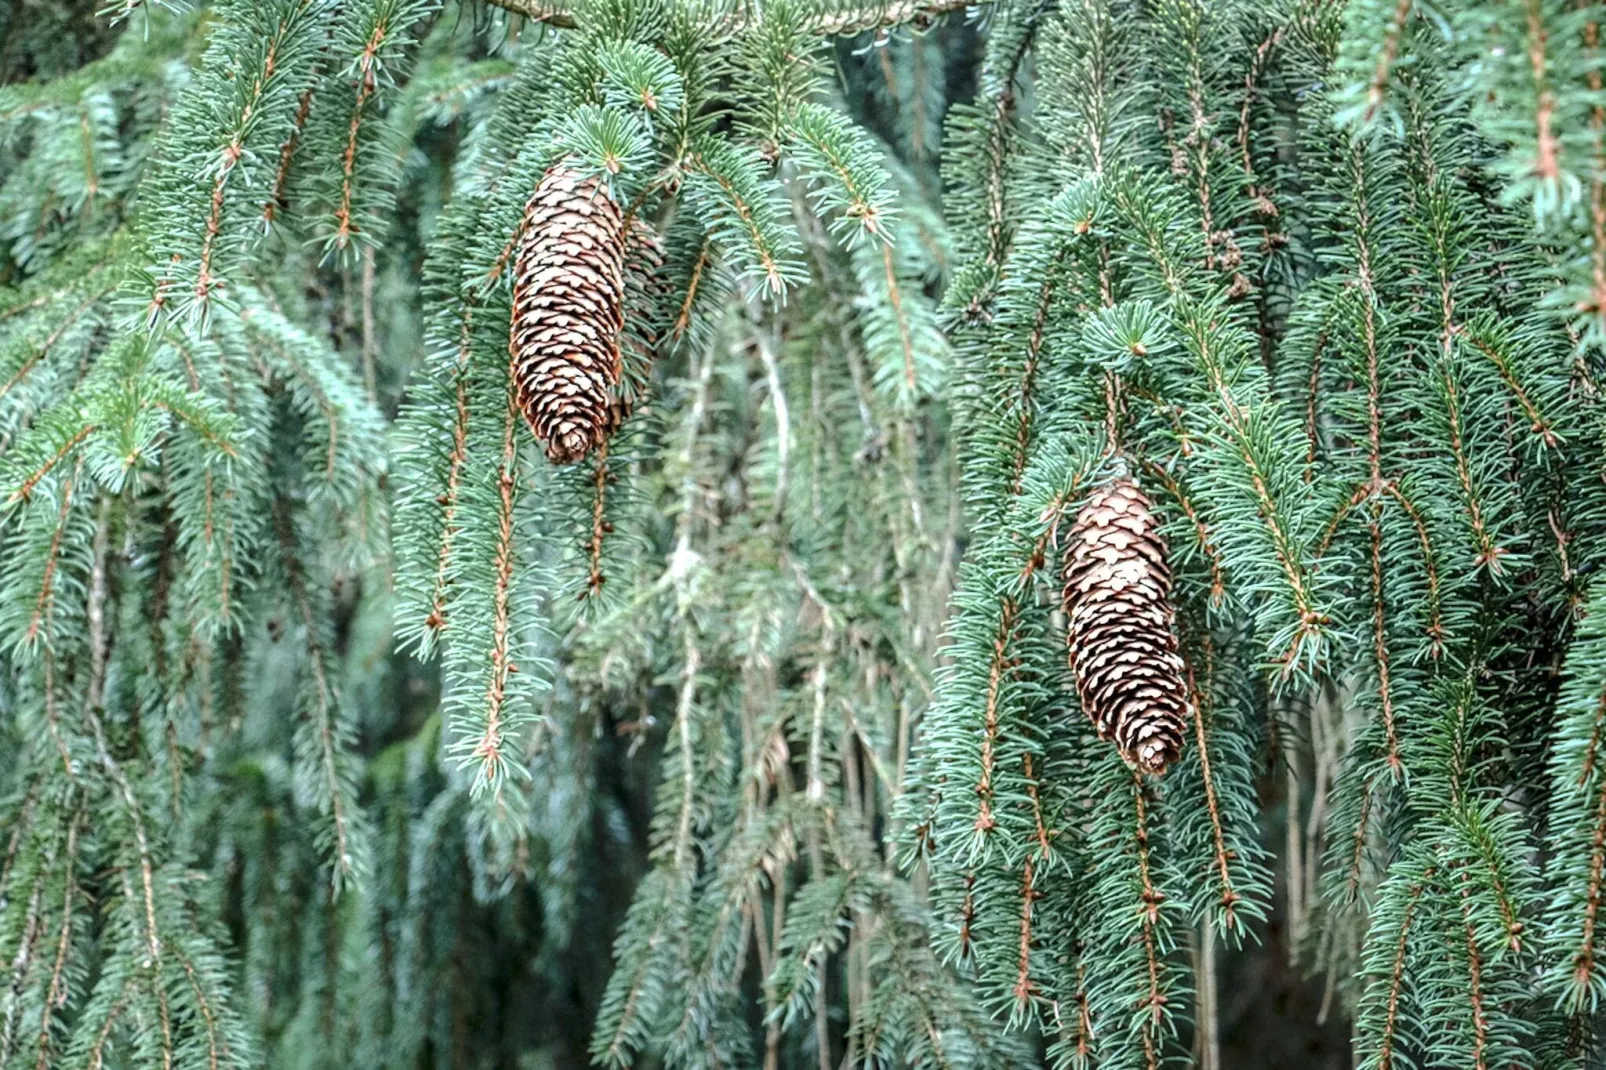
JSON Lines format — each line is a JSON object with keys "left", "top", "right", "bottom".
{"left": 1065, "top": 477, "right": 1190, "bottom": 773}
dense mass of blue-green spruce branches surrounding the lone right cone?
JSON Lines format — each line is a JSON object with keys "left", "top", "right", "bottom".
{"left": 904, "top": 3, "right": 1600, "bottom": 1067}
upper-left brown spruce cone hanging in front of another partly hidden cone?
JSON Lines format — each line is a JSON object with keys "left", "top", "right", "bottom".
{"left": 511, "top": 162, "right": 625, "bottom": 464}
